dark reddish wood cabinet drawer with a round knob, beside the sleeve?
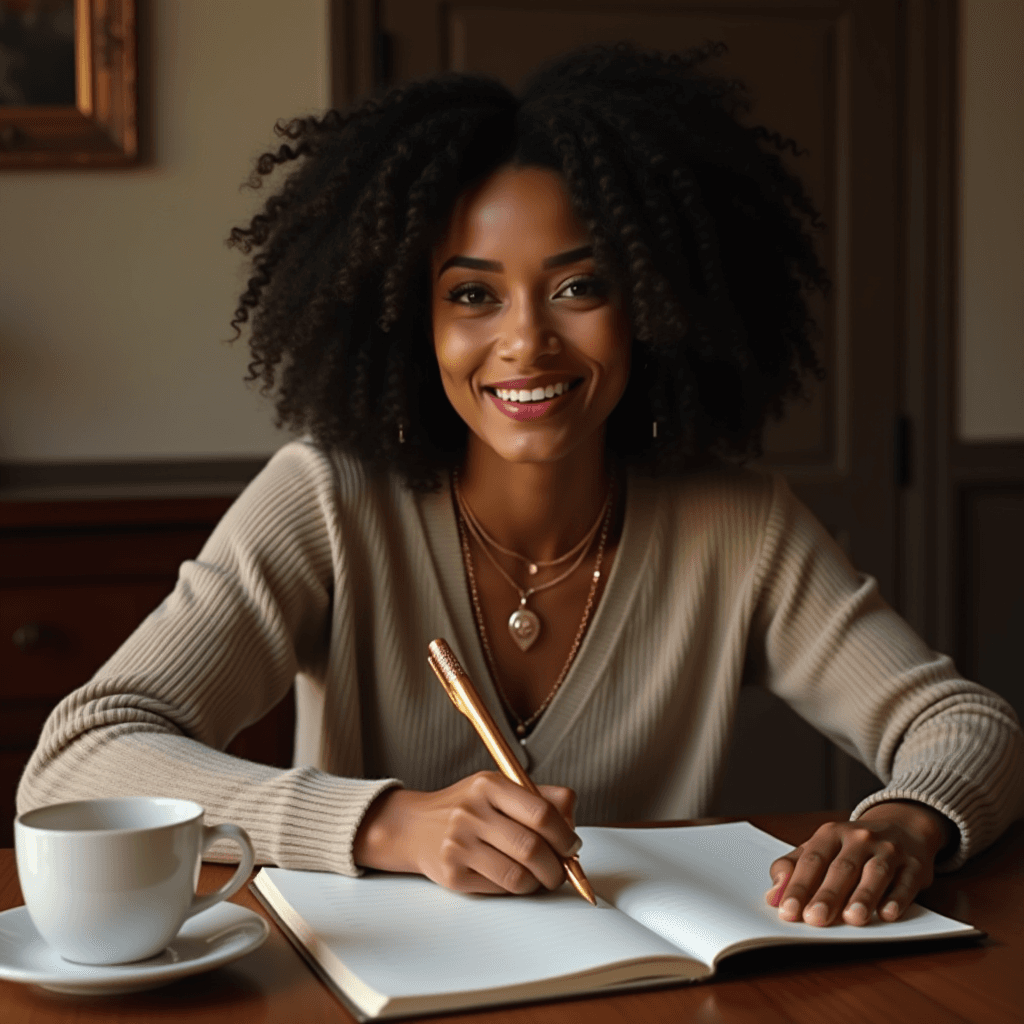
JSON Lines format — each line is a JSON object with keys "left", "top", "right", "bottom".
{"left": 0, "top": 579, "right": 174, "bottom": 702}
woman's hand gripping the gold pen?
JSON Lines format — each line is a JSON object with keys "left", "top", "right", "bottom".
{"left": 352, "top": 771, "right": 581, "bottom": 895}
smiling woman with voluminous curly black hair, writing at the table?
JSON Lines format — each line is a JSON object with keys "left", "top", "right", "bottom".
{"left": 19, "top": 46, "right": 1024, "bottom": 925}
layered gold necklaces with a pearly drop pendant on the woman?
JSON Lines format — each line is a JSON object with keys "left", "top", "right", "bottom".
{"left": 452, "top": 472, "right": 614, "bottom": 740}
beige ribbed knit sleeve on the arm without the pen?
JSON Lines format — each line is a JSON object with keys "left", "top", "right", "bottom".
{"left": 754, "top": 478, "right": 1024, "bottom": 869}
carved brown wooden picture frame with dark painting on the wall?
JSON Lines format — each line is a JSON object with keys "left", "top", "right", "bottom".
{"left": 0, "top": 0, "right": 138, "bottom": 170}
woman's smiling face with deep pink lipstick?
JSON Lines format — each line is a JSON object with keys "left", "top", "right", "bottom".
{"left": 431, "top": 167, "right": 630, "bottom": 462}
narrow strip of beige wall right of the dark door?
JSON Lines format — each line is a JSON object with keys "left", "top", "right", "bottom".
{"left": 958, "top": 0, "right": 1024, "bottom": 441}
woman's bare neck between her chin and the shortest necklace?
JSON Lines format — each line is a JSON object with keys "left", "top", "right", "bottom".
{"left": 459, "top": 436, "right": 609, "bottom": 561}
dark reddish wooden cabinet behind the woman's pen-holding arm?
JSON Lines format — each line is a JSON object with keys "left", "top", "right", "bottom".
{"left": 0, "top": 497, "right": 294, "bottom": 847}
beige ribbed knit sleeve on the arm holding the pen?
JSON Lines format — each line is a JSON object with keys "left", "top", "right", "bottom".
{"left": 17, "top": 443, "right": 394, "bottom": 873}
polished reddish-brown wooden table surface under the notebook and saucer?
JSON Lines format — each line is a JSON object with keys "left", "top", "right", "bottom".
{"left": 0, "top": 814, "right": 1024, "bottom": 1024}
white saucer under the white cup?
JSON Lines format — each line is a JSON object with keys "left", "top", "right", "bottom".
{"left": 0, "top": 903, "right": 270, "bottom": 995}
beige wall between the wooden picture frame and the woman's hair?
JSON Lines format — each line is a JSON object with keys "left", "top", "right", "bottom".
{"left": 0, "top": 0, "right": 329, "bottom": 463}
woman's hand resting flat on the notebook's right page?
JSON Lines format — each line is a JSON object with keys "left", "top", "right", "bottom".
{"left": 766, "top": 801, "right": 954, "bottom": 926}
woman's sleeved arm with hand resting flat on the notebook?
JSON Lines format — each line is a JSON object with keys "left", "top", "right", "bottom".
{"left": 751, "top": 479, "right": 1024, "bottom": 924}
